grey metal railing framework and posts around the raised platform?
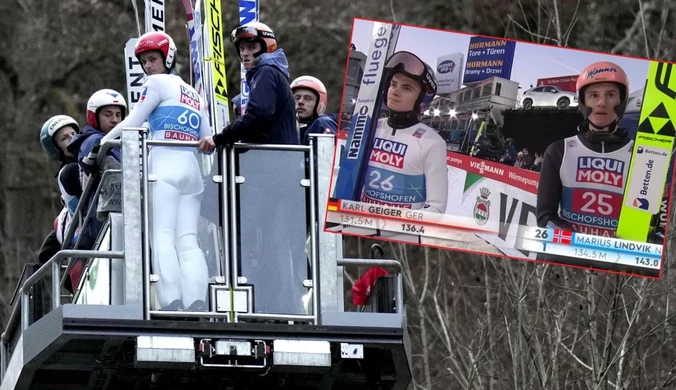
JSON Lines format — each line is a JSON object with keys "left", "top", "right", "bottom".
{"left": 0, "top": 128, "right": 404, "bottom": 380}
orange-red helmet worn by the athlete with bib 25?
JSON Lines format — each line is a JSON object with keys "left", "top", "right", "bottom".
{"left": 576, "top": 61, "right": 629, "bottom": 119}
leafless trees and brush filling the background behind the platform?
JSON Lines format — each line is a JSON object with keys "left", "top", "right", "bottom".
{"left": 0, "top": 0, "right": 676, "bottom": 390}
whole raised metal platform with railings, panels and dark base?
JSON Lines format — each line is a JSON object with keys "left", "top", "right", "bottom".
{"left": 0, "top": 128, "right": 411, "bottom": 390}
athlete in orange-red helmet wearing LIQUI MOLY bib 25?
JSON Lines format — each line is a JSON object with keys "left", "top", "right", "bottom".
{"left": 536, "top": 62, "right": 633, "bottom": 237}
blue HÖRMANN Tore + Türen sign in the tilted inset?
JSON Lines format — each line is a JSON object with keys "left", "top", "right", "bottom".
{"left": 462, "top": 37, "right": 516, "bottom": 84}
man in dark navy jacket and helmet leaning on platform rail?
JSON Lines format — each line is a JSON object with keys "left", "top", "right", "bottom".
{"left": 199, "top": 22, "right": 300, "bottom": 151}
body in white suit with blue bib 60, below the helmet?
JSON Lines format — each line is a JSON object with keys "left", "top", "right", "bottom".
{"left": 101, "top": 74, "right": 211, "bottom": 310}
